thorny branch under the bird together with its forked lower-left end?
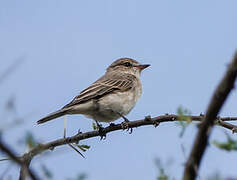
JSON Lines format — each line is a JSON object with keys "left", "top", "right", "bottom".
{"left": 0, "top": 114, "right": 237, "bottom": 179}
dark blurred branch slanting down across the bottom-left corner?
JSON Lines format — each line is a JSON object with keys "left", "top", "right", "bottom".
{"left": 0, "top": 140, "right": 38, "bottom": 180}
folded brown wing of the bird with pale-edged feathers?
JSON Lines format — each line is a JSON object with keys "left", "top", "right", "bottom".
{"left": 63, "top": 74, "right": 136, "bottom": 108}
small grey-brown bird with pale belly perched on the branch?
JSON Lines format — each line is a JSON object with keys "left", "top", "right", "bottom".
{"left": 37, "top": 58, "right": 150, "bottom": 125}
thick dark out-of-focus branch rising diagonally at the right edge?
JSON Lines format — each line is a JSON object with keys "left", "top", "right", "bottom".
{"left": 183, "top": 52, "right": 237, "bottom": 180}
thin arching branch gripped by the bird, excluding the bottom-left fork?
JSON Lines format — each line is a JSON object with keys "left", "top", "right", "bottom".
{"left": 19, "top": 115, "right": 237, "bottom": 165}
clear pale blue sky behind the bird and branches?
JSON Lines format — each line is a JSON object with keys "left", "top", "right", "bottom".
{"left": 0, "top": 0, "right": 237, "bottom": 180}
